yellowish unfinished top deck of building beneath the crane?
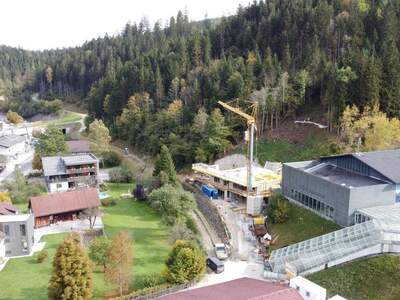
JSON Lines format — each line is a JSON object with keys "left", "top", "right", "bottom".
{"left": 192, "top": 163, "right": 281, "bottom": 186}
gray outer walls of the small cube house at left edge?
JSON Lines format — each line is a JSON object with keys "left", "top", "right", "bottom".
{"left": 2, "top": 215, "right": 34, "bottom": 257}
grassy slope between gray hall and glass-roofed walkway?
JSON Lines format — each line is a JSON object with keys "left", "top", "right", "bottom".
{"left": 270, "top": 203, "right": 341, "bottom": 249}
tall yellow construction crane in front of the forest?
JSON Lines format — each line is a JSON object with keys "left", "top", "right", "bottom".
{"left": 218, "top": 101, "right": 258, "bottom": 192}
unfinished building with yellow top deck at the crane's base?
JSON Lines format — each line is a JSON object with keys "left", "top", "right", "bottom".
{"left": 192, "top": 163, "right": 281, "bottom": 215}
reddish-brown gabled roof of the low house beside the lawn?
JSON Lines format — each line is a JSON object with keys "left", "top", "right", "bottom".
{"left": 29, "top": 188, "right": 101, "bottom": 217}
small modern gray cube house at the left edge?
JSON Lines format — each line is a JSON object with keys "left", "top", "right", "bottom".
{"left": 0, "top": 214, "right": 35, "bottom": 257}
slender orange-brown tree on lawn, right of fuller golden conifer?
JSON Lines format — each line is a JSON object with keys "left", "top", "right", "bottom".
{"left": 104, "top": 231, "right": 133, "bottom": 296}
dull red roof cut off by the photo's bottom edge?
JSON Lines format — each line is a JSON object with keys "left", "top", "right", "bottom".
{"left": 160, "top": 278, "right": 303, "bottom": 300}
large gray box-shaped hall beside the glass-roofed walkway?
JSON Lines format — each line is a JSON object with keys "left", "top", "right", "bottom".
{"left": 282, "top": 150, "right": 400, "bottom": 226}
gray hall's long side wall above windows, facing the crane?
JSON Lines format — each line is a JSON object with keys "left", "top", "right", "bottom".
{"left": 282, "top": 164, "right": 350, "bottom": 226}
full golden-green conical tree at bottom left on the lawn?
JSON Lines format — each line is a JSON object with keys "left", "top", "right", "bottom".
{"left": 48, "top": 235, "right": 93, "bottom": 300}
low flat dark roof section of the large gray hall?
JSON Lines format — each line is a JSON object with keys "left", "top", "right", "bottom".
{"left": 305, "top": 163, "right": 386, "bottom": 188}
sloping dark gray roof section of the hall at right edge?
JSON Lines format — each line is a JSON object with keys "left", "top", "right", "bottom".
{"left": 352, "top": 149, "right": 400, "bottom": 183}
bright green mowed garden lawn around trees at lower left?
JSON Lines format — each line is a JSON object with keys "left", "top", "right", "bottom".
{"left": 0, "top": 184, "right": 170, "bottom": 300}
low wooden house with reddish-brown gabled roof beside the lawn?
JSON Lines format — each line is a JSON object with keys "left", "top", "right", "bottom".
{"left": 29, "top": 188, "right": 101, "bottom": 228}
